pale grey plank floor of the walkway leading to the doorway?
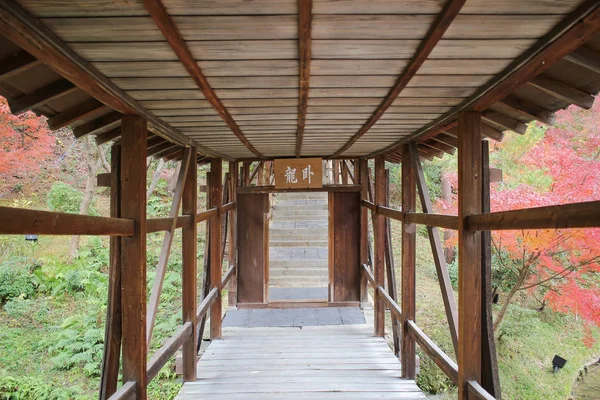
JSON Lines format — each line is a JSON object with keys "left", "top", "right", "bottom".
{"left": 176, "top": 324, "right": 425, "bottom": 400}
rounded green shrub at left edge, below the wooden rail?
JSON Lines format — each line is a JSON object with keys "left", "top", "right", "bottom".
{"left": 0, "top": 257, "right": 35, "bottom": 304}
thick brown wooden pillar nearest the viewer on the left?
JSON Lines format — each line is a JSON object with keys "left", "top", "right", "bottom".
{"left": 121, "top": 115, "right": 147, "bottom": 400}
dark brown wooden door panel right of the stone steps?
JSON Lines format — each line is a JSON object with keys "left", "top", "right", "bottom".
{"left": 329, "top": 192, "right": 360, "bottom": 302}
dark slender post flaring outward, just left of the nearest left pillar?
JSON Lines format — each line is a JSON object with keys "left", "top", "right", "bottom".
{"left": 98, "top": 145, "right": 121, "bottom": 400}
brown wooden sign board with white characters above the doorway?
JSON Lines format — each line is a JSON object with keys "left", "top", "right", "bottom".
{"left": 273, "top": 158, "right": 323, "bottom": 189}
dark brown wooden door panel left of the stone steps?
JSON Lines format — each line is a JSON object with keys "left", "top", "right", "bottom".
{"left": 237, "top": 193, "right": 269, "bottom": 304}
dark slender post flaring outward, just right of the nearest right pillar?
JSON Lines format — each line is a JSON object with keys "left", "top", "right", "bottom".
{"left": 481, "top": 140, "right": 502, "bottom": 399}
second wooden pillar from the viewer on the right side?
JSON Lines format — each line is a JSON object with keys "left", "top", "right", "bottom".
{"left": 401, "top": 144, "right": 417, "bottom": 379}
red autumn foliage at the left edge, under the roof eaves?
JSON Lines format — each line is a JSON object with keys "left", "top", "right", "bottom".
{"left": 0, "top": 97, "right": 55, "bottom": 187}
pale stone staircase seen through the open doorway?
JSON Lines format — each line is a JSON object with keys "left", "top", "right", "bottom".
{"left": 269, "top": 193, "right": 329, "bottom": 288}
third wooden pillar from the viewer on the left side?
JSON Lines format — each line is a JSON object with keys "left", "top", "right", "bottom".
{"left": 210, "top": 158, "right": 223, "bottom": 339}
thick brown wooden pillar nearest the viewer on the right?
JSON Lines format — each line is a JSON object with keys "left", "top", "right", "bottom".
{"left": 458, "top": 111, "right": 483, "bottom": 399}
